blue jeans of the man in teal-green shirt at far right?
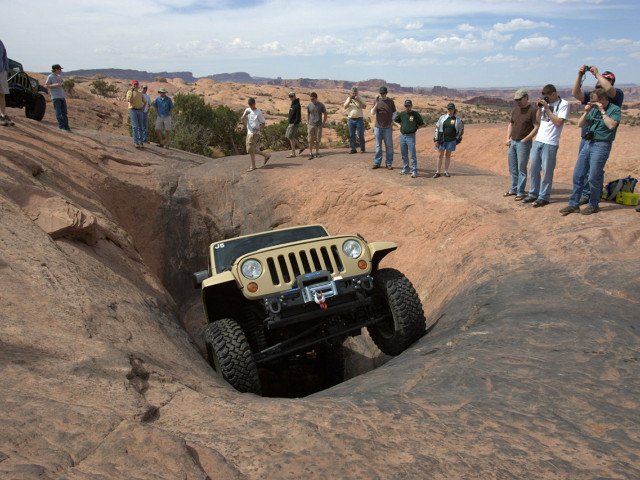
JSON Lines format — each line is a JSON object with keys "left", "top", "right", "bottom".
{"left": 569, "top": 141, "right": 612, "bottom": 208}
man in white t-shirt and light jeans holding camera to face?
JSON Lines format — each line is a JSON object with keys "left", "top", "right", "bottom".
{"left": 522, "top": 83, "right": 569, "bottom": 207}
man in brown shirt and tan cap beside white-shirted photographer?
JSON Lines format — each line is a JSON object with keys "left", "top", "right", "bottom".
{"left": 504, "top": 88, "right": 539, "bottom": 200}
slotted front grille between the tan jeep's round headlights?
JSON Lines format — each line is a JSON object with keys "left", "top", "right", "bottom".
{"left": 267, "top": 245, "right": 344, "bottom": 285}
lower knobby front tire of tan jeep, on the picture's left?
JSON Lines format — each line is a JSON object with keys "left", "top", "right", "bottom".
{"left": 204, "top": 318, "right": 262, "bottom": 395}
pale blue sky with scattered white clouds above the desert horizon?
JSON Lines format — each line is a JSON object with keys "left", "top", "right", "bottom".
{"left": 0, "top": 0, "right": 640, "bottom": 88}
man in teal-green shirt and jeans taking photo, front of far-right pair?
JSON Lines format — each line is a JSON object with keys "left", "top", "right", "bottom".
{"left": 560, "top": 88, "right": 621, "bottom": 215}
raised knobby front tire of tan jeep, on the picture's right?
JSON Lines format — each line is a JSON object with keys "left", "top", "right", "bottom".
{"left": 367, "top": 268, "right": 426, "bottom": 355}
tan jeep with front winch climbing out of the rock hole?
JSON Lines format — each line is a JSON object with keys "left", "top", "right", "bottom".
{"left": 194, "top": 225, "right": 426, "bottom": 394}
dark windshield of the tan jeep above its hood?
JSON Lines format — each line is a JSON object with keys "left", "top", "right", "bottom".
{"left": 213, "top": 225, "right": 329, "bottom": 273}
